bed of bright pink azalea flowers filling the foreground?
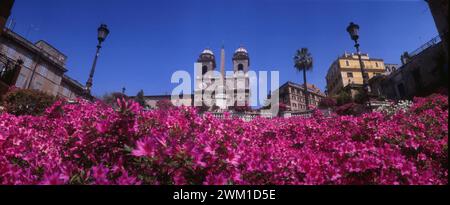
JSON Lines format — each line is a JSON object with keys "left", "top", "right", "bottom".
{"left": 0, "top": 95, "right": 448, "bottom": 185}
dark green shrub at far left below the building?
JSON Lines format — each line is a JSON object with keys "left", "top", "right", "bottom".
{"left": 2, "top": 89, "right": 57, "bottom": 115}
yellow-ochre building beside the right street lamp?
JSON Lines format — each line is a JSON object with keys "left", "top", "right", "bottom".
{"left": 326, "top": 53, "right": 386, "bottom": 96}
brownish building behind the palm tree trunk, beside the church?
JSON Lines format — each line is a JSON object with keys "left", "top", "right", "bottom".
{"left": 275, "top": 81, "right": 326, "bottom": 111}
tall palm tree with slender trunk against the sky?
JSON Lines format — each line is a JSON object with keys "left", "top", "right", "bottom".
{"left": 294, "top": 48, "right": 313, "bottom": 110}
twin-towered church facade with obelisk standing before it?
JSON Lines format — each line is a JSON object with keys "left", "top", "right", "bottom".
{"left": 194, "top": 46, "right": 250, "bottom": 110}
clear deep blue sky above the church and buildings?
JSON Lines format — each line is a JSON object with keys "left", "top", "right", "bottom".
{"left": 7, "top": 0, "right": 437, "bottom": 96}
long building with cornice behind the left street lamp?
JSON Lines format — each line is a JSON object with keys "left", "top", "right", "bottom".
{"left": 0, "top": 29, "right": 84, "bottom": 99}
